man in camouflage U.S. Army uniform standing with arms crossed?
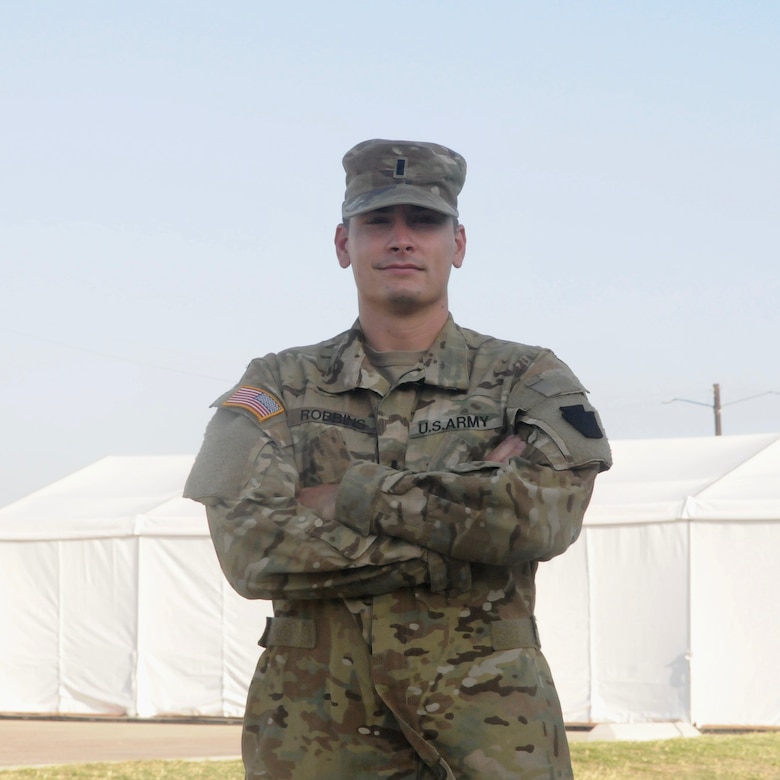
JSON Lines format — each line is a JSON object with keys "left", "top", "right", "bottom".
{"left": 185, "top": 140, "right": 610, "bottom": 780}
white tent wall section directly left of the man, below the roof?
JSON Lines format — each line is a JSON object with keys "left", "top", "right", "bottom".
{"left": 135, "top": 538, "right": 270, "bottom": 717}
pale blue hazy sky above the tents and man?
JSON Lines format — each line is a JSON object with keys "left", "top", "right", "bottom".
{"left": 0, "top": 0, "right": 780, "bottom": 505}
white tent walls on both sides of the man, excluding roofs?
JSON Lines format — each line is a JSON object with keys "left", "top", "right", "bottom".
{"left": 0, "top": 521, "right": 780, "bottom": 726}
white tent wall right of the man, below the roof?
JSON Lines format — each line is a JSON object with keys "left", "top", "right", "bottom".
{"left": 537, "top": 520, "right": 780, "bottom": 726}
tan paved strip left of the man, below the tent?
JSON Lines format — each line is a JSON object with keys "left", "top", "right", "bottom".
{"left": 0, "top": 718, "right": 241, "bottom": 770}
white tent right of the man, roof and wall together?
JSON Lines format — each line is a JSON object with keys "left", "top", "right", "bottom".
{"left": 537, "top": 434, "right": 780, "bottom": 726}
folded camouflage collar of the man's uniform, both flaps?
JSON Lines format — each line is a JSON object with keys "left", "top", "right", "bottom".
{"left": 320, "top": 315, "right": 469, "bottom": 395}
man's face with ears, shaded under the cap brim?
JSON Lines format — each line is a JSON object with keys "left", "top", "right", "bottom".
{"left": 335, "top": 206, "right": 466, "bottom": 315}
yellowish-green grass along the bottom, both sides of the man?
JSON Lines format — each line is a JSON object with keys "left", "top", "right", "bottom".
{"left": 0, "top": 732, "right": 780, "bottom": 780}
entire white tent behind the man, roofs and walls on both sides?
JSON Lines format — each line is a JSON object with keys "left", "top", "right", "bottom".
{"left": 0, "top": 434, "right": 780, "bottom": 726}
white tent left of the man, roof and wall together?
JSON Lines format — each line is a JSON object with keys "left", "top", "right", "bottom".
{"left": 0, "top": 456, "right": 270, "bottom": 717}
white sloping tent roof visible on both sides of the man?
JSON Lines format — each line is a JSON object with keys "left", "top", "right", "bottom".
{"left": 0, "top": 433, "right": 780, "bottom": 540}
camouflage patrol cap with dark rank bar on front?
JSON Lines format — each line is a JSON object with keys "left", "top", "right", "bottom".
{"left": 341, "top": 138, "right": 466, "bottom": 219}
